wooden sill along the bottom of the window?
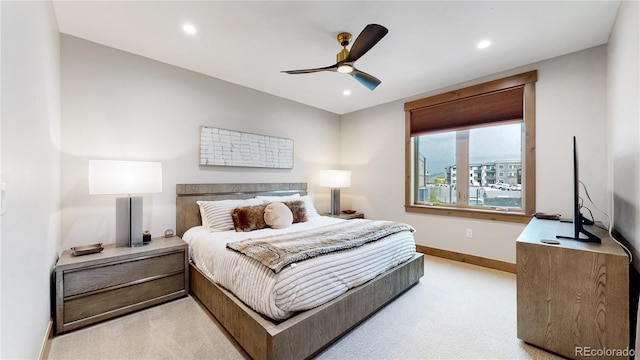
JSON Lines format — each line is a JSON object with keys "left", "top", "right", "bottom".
{"left": 404, "top": 205, "right": 532, "bottom": 224}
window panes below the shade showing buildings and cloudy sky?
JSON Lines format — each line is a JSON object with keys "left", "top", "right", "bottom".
{"left": 415, "top": 123, "right": 522, "bottom": 209}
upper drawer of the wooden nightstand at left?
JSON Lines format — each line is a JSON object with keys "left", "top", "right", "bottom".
{"left": 63, "top": 251, "right": 184, "bottom": 298}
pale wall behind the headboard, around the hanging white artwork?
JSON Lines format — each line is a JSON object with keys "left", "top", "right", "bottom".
{"left": 61, "top": 35, "right": 340, "bottom": 248}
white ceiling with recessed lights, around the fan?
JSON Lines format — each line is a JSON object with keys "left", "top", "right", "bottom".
{"left": 54, "top": 0, "right": 620, "bottom": 114}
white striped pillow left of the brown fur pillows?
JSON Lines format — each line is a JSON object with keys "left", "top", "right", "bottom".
{"left": 197, "top": 199, "right": 263, "bottom": 231}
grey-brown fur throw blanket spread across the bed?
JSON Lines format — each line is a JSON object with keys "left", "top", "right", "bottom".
{"left": 227, "top": 219, "right": 415, "bottom": 273}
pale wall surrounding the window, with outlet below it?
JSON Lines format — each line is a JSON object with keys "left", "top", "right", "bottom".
{"left": 342, "top": 46, "right": 609, "bottom": 263}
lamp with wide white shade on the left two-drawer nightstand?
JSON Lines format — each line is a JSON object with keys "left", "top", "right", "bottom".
{"left": 89, "top": 160, "right": 162, "bottom": 247}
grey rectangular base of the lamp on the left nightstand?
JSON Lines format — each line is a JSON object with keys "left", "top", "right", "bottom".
{"left": 116, "top": 196, "right": 144, "bottom": 247}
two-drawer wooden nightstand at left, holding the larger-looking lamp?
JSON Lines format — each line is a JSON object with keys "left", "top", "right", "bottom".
{"left": 55, "top": 236, "right": 189, "bottom": 334}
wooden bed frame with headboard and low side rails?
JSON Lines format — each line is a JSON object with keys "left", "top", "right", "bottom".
{"left": 176, "top": 183, "right": 424, "bottom": 360}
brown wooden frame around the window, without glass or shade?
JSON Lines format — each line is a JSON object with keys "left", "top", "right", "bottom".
{"left": 404, "top": 70, "right": 538, "bottom": 223}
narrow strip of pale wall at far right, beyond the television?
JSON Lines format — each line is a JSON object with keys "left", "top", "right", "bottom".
{"left": 607, "top": 1, "right": 640, "bottom": 270}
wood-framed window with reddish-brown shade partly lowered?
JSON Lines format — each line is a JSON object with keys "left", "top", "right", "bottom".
{"left": 405, "top": 71, "right": 537, "bottom": 222}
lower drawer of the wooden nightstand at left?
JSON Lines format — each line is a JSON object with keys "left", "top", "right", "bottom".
{"left": 64, "top": 272, "right": 185, "bottom": 324}
